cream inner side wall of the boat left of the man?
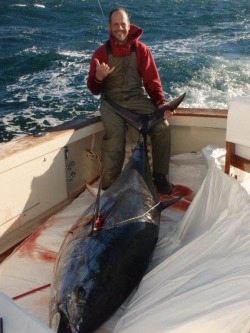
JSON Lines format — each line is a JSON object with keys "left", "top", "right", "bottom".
{"left": 0, "top": 123, "right": 103, "bottom": 253}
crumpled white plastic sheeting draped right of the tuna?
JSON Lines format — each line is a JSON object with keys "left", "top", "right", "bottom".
{"left": 114, "top": 147, "right": 250, "bottom": 333}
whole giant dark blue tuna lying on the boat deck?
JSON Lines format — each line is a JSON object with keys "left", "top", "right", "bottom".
{"left": 50, "top": 95, "right": 184, "bottom": 333}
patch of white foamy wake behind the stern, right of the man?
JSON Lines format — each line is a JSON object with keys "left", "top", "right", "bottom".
{"left": 170, "top": 58, "right": 250, "bottom": 109}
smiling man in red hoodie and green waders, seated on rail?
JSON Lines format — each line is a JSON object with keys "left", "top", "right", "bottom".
{"left": 87, "top": 8, "right": 173, "bottom": 194}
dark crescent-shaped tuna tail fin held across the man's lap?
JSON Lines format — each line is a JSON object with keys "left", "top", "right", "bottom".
{"left": 105, "top": 93, "right": 186, "bottom": 134}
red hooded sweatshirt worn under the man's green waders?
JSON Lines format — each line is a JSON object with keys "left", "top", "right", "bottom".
{"left": 87, "top": 24, "right": 166, "bottom": 106}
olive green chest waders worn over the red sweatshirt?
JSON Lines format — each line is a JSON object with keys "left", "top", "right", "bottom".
{"left": 100, "top": 40, "right": 170, "bottom": 189}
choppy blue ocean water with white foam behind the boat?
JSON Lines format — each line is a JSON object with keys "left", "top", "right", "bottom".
{"left": 0, "top": 0, "right": 250, "bottom": 142}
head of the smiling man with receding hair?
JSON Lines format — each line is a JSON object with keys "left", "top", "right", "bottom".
{"left": 108, "top": 11, "right": 130, "bottom": 44}
